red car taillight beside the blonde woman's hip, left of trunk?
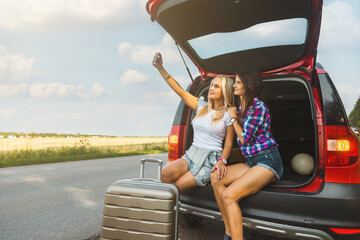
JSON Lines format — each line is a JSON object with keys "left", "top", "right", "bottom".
{"left": 168, "top": 125, "right": 184, "bottom": 162}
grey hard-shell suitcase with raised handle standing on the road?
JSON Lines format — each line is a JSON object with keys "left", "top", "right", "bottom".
{"left": 101, "top": 158, "right": 179, "bottom": 240}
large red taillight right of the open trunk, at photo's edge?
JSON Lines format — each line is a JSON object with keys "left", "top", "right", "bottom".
{"left": 325, "top": 126, "right": 360, "bottom": 183}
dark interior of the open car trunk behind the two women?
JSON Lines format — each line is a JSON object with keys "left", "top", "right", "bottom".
{"left": 185, "top": 76, "right": 318, "bottom": 187}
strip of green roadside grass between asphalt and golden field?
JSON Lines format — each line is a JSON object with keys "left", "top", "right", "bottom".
{"left": 0, "top": 142, "right": 167, "bottom": 168}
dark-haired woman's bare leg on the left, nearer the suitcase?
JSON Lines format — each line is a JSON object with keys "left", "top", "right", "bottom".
{"left": 210, "top": 163, "right": 249, "bottom": 236}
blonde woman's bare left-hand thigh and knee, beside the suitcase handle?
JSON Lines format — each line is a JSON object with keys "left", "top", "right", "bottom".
{"left": 161, "top": 158, "right": 189, "bottom": 183}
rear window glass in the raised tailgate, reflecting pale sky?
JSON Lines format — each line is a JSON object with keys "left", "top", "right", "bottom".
{"left": 188, "top": 18, "right": 308, "bottom": 59}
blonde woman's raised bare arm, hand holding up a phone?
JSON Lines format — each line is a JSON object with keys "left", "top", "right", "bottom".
{"left": 152, "top": 52, "right": 198, "bottom": 110}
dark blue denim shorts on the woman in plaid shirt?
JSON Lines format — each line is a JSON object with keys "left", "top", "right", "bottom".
{"left": 245, "top": 146, "right": 284, "bottom": 180}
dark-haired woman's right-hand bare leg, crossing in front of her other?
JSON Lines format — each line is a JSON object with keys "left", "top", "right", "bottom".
{"left": 221, "top": 166, "right": 275, "bottom": 240}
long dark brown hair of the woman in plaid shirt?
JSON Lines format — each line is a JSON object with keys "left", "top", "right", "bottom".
{"left": 236, "top": 70, "right": 264, "bottom": 122}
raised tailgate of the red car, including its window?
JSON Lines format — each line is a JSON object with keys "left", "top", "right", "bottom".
{"left": 146, "top": 0, "right": 322, "bottom": 77}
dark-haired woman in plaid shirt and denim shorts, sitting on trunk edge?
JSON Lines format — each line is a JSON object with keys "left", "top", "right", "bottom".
{"left": 211, "top": 71, "right": 283, "bottom": 240}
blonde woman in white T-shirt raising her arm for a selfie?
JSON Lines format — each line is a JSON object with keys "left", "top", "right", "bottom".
{"left": 152, "top": 53, "right": 235, "bottom": 192}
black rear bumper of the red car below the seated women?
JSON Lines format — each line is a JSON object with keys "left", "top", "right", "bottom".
{"left": 180, "top": 183, "right": 360, "bottom": 240}
